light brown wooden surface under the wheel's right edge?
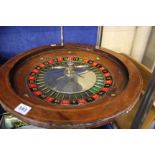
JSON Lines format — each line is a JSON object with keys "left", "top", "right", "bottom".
{"left": 115, "top": 54, "right": 155, "bottom": 129}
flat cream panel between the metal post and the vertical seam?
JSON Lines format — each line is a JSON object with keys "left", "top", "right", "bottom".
{"left": 102, "top": 26, "right": 136, "bottom": 55}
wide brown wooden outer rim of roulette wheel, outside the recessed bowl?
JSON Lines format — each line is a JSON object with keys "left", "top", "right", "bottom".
{"left": 0, "top": 44, "right": 143, "bottom": 128}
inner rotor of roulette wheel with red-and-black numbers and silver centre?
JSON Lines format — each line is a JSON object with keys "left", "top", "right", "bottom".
{"left": 28, "top": 56, "right": 113, "bottom": 106}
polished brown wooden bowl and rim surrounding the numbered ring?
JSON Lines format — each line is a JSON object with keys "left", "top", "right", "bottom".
{"left": 0, "top": 44, "right": 143, "bottom": 128}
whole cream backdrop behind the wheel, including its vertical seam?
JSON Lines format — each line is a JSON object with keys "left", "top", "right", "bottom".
{"left": 102, "top": 26, "right": 151, "bottom": 62}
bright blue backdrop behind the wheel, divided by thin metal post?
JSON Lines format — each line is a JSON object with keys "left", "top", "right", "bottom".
{"left": 0, "top": 26, "right": 97, "bottom": 63}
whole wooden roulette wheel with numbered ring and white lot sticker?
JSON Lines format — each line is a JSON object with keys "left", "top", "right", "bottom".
{"left": 0, "top": 44, "right": 142, "bottom": 128}
